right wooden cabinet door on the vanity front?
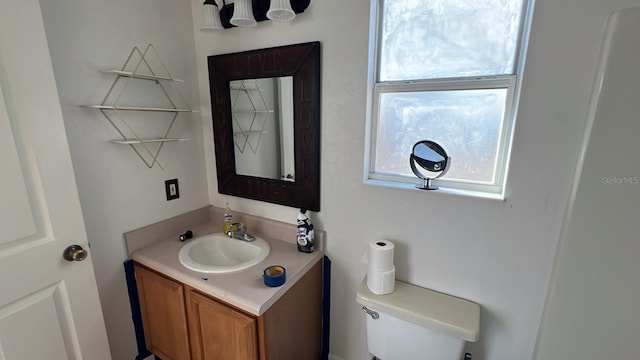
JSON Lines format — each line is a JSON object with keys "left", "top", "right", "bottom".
{"left": 187, "top": 290, "right": 258, "bottom": 360}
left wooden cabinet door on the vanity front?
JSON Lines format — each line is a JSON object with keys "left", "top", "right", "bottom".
{"left": 135, "top": 264, "right": 190, "bottom": 360}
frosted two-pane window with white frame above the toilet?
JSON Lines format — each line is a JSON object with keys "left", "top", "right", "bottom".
{"left": 367, "top": 0, "right": 528, "bottom": 197}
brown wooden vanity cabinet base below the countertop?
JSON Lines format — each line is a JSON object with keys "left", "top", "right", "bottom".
{"left": 135, "top": 261, "right": 322, "bottom": 360}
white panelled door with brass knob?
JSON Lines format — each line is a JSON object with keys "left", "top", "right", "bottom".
{"left": 0, "top": 0, "right": 111, "bottom": 360}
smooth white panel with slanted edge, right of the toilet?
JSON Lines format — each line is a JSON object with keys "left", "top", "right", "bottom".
{"left": 536, "top": 7, "right": 640, "bottom": 360}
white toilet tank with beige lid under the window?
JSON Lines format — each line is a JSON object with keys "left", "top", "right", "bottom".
{"left": 356, "top": 277, "right": 480, "bottom": 360}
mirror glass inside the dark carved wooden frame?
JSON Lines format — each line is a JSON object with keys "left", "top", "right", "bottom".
{"left": 229, "top": 76, "right": 295, "bottom": 181}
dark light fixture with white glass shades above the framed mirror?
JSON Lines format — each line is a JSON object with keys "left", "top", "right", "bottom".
{"left": 200, "top": 0, "right": 311, "bottom": 31}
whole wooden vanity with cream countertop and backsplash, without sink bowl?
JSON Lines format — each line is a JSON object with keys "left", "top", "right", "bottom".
{"left": 125, "top": 207, "right": 324, "bottom": 360}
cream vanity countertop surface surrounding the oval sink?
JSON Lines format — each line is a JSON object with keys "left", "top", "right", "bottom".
{"left": 131, "top": 224, "right": 324, "bottom": 316}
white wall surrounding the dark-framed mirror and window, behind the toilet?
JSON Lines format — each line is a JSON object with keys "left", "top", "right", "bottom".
{"left": 192, "top": 0, "right": 637, "bottom": 360}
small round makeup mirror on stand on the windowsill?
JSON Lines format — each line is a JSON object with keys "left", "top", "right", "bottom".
{"left": 409, "top": 140, "right": 451, "bottom": 190}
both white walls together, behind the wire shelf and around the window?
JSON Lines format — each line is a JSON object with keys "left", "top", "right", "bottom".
{"left": 34, "top": 0, "right": 638, "bottom": 360}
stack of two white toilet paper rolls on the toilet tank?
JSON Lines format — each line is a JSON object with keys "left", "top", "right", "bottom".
{"left": 367, "top": 240, "right": 396, "bottom": 295}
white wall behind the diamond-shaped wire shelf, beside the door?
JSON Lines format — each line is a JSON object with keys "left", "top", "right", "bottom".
{"left": 40, "top": 0, "right": 208, "bottom": 359}
